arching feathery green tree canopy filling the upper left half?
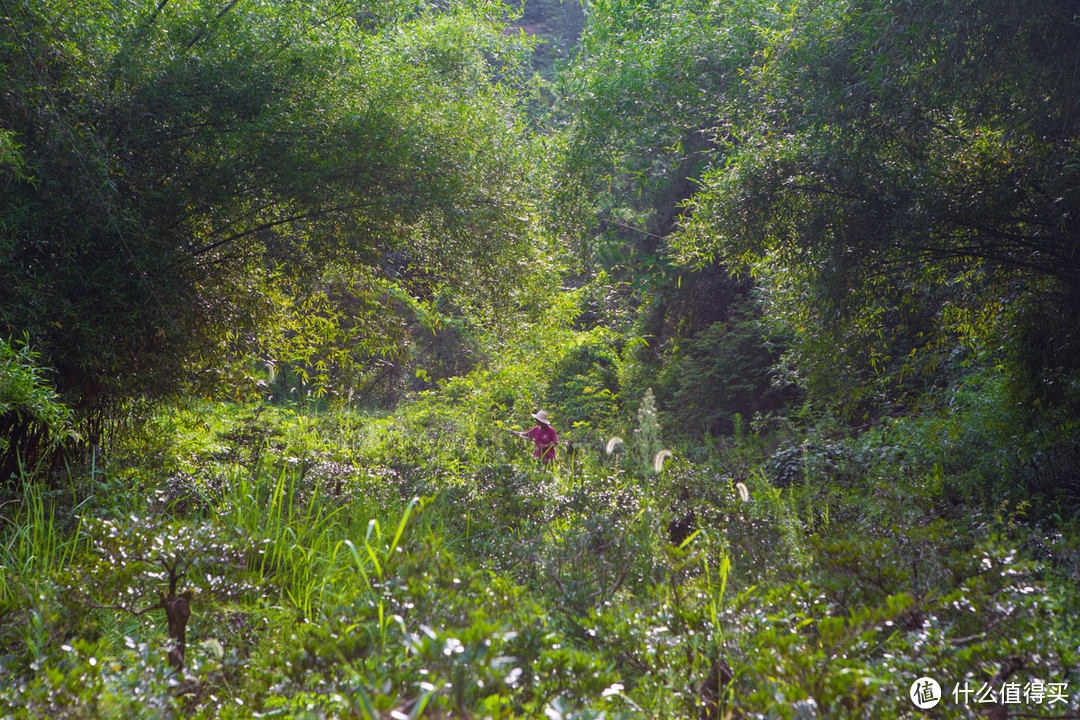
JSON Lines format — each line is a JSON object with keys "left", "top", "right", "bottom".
{"left": 0, "top": 0, "right": 540, "bottom": 418}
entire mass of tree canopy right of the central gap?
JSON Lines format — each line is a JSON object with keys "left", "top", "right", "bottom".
{"left": 553, "top": 0, "right": 1080, "bottom": 416}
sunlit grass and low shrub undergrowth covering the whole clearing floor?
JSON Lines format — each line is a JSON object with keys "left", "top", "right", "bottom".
{"left": 0, "top": 397, "right": 1080, "bottom": 719}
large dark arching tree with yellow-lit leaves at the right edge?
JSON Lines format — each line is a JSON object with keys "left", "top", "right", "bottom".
{"left": 681, "top": 0, "right": 1080, "bottom": 413}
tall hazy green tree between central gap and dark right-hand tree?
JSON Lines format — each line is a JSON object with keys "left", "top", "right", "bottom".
{"left": 552, "top": 0, "right": 785, "bottom": 432}
